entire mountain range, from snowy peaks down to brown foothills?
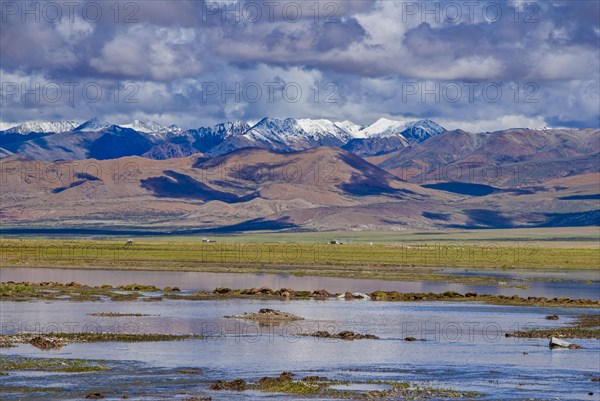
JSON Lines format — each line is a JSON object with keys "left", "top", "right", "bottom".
{"left": 0, "top": 118, "right": 600, "bottom": 233}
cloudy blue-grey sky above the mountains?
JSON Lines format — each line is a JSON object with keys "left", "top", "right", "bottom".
{"left": 0, "top": 0, "right": 600, "bottom": 132}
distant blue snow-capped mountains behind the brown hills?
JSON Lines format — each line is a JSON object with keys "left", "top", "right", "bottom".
{"left": 0, "top": 118, "right": 444, "bottom": 161}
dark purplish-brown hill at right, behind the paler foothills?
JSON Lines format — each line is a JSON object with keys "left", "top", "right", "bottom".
{"left": 378, "top": 129, "right": 600, "bottom": 188}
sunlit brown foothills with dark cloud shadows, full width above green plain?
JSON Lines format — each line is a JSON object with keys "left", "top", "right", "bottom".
{"left": 0, "top": 144, "right": 600, "bottom": 232}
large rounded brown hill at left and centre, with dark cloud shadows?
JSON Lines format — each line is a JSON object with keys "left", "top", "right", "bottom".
{"left": 0, "top": 147, "right": 457, "bottom": 231}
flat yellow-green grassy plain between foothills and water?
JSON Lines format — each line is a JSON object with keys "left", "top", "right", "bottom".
{"left": 0, "top": 227, "right": 600, "bottom": 282}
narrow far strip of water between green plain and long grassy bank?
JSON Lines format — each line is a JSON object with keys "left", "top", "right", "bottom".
{"left": 0, "top": 268, "right": 600, "bottom": 299}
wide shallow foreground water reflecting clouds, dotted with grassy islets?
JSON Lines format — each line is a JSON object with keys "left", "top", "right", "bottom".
{"left": 1, "top": 298, "right": 600, "bottom": 401}
